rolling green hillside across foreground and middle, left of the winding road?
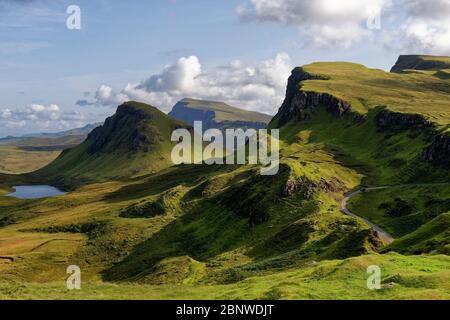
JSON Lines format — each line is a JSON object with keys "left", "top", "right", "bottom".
{"left": 0, "top": 62, "right": 449, "bottom": 299}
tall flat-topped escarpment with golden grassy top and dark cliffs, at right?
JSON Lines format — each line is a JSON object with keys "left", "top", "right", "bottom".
{"left": 270, "top": 59, "right": 450, "bottom": 168}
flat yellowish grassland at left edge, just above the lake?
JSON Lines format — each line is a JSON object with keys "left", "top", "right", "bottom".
{"left": 0, "top": 145, "right": 60, "bottom": 174}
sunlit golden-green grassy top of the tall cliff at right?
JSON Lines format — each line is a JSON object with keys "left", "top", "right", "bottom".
{"left": 302, "top": 62, "right": 450, "bottom": 127}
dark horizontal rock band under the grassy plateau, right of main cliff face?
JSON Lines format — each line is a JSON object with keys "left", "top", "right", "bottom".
{"left": 375, "top": 110, "right": 433, "bottom": 131}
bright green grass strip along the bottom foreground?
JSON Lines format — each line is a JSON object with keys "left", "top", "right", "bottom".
{"left": 0, "top": 253, "right": 450, "bottom": 300}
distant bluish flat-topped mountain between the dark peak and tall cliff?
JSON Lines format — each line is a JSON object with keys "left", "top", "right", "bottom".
{"left": 169, "top": 99, "right": 272, "bottom": 130}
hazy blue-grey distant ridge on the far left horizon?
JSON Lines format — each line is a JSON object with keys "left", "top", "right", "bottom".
{"left": 0, "top": 123, "right": 101, "bottom": 151}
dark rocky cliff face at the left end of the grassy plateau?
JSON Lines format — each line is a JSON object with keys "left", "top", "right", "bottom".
{"left": 275, "top": 68, "right": 351, "bottom": 127}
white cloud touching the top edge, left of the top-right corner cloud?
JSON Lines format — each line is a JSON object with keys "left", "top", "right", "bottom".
{"left": 237, "top": 0, "right": 391, "bottom": 47}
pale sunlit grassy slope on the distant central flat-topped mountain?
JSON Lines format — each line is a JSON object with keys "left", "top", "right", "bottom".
{"left": 179, "top": 99, "right": 272, "bottom": 123}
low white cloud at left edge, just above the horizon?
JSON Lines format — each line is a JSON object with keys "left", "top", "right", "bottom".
{"left": 0, "top": 104, "right": 85, "bottom": 130}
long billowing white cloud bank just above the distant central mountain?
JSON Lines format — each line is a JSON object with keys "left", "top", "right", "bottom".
{"left": 85, "top": 53, "right": 292, "bottom": 113}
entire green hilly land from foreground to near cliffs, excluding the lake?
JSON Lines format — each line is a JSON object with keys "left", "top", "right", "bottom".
{"left": 0, "top": 57, "right": 450, "bottom": 299}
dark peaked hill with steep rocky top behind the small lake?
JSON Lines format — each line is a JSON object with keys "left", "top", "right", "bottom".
{"left": 36, "top": 102, "right": 190, "bottom": 186}
